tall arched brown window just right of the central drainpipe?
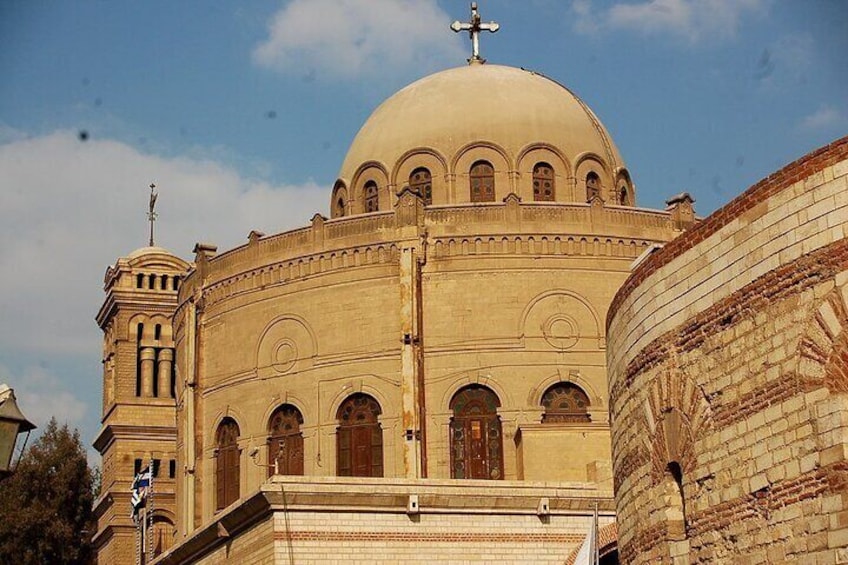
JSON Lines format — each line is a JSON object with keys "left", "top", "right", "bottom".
{"left": 450, "top": 385, "right": 504, "bottom": 479}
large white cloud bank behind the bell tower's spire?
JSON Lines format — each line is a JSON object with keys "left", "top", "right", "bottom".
{"left": 0, "top": 131, "right": 329, "bottom": 356}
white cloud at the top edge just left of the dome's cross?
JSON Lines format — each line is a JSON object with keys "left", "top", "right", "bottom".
{"left": 253, "top": 0, "right": 467, "bottom": 78}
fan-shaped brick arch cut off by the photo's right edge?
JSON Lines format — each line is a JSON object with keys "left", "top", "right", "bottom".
{"left": 798, "top": 271, "right": 848, "bottom": 394}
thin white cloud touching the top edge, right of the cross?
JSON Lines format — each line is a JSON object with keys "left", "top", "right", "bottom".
{"left": 572, "top": 0, "right": 769, "bottom": 43}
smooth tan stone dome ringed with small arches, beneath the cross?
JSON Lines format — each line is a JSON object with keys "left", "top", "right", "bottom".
{"left": 333, "top": 64, "right": 632, "bottom": 216}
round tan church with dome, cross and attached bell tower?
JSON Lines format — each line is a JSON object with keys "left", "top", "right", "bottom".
{"left": 94, "top": 5, "right": 846, "bottom": 564}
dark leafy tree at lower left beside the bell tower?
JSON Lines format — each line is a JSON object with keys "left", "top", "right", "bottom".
{"left": 0, "top": 419, "right": 95, "bottom": 565}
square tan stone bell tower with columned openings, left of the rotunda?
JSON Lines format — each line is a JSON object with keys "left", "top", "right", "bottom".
{"left": 93, "top": 246, "right": 191, "bottom": 564}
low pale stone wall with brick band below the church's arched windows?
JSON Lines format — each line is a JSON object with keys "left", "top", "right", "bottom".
{"left": 157, "top": 477, "right": 614, "bottom": 565}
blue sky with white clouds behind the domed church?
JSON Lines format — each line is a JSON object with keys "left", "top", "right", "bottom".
{"left": 0, "top": 0, "right": 848, "bottom": 458}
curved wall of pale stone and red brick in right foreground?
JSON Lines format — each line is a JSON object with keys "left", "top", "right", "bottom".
{"left": 607, "top": 138, "right": 848, "bottom": 563}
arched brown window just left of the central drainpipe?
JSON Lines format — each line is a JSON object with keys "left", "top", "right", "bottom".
{"left": 336, "top": 392, "right": 383, "bottom": 477}
